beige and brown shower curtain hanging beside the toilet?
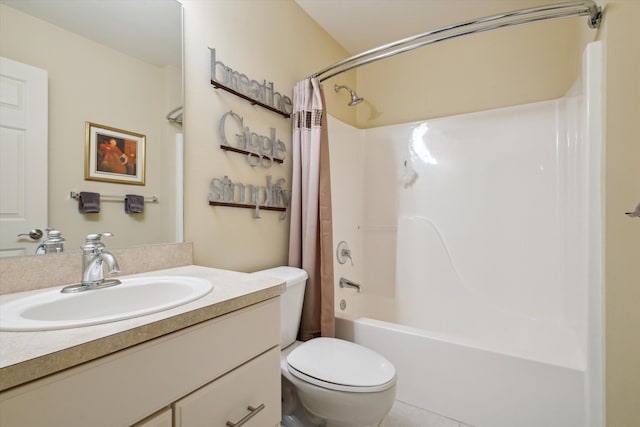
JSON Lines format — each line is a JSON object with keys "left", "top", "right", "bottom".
{"left": 289, "top": 78, "right": 335, "bottom": 341}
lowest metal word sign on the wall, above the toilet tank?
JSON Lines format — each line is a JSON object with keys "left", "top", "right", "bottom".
{"left": 209, "top": 175, "right": 291, "bottom": 220}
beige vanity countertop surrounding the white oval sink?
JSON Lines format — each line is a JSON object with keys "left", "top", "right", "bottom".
{"left": 0, "top": 265, "right": 285, "bottom": 391}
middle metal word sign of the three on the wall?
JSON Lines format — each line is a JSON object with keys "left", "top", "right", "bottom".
{"left": 218, "top": 111, "right": 287, "bottom": 168}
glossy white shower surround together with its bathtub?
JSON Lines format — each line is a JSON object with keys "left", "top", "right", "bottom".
{"left": 330, "top": 43, "right": 603, "bottom": 427}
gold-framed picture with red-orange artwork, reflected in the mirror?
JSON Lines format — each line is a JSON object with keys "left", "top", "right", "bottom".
{"left": 84, "top": 122, "right": 146, "bottom": 185}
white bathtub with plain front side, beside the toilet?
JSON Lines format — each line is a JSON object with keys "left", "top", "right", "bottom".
{"left": 336, "top": 317, "right": 585, "bottom": 427}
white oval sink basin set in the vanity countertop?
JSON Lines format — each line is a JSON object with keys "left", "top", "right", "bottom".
{"left": 0, "top": 276, "right": 213, "bottom": 331}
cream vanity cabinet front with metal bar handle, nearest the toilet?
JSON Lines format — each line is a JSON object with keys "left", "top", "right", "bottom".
{"left": 173, "top": 347, "right": 280, "bottom": 427}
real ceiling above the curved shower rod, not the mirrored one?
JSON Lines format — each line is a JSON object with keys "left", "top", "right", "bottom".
{"left": 295, "top": 0, "right": 563, "bottom": 55}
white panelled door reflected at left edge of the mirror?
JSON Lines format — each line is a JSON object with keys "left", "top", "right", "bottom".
{"left": 0, "top": 57, "right": 48, "bottom": 256}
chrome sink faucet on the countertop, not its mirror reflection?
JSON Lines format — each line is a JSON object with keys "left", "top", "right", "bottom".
{"left": 61, "top": 233, "right": 120, "bottom": 292}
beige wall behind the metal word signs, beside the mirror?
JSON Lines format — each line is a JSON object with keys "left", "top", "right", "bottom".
{"left": 183, "top": 0, "right": 354, "bottom": 271}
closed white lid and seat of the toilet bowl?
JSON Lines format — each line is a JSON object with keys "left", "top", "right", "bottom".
{"left": 287, "top": 338, "right": 396, "bottom": 392}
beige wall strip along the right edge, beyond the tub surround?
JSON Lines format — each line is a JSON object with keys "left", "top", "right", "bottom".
{"left": 600, "top": 1, "right": 640, "bottom": 427}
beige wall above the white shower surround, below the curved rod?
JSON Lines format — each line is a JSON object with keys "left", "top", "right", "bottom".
{"left": 356, "top": 18, "right": 587, "bottom": 128}
